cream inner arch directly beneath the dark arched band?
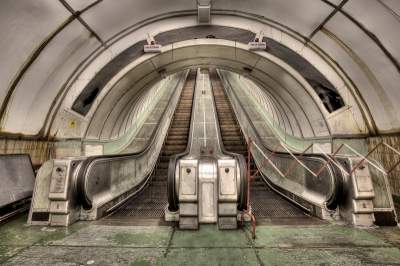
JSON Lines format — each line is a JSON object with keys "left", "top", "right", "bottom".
{"left": 78, "top": 39, "right": 329, "bottom": 138}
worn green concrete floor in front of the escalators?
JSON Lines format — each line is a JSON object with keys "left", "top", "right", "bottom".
{"left": 0, "top": 216, "right": 400, "bottom": 265}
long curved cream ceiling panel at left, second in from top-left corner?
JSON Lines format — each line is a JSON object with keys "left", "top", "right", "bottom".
{"left": 4, "top": 20, "right": 99, "bottom": 134}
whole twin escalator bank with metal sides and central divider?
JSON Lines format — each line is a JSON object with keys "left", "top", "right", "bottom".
{"left": 28, "top": 70, "right": 396, "bottom": 229}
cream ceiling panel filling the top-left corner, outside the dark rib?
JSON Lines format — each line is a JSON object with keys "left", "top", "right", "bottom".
{"left": 0, "top": 0, "right": 70, "bottom": 108}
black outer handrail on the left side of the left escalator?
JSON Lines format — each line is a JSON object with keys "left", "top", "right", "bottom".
{"left": 75, "top": 73, "right": 187, "bottom": 210}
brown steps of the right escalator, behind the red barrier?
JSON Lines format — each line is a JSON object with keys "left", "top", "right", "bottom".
{"left": 210, "top": 71, "right": 316, "bottom": 223}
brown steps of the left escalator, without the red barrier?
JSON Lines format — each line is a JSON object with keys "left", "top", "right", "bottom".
{"left": 99, "top": 70, "right": 196, "bottom": 225}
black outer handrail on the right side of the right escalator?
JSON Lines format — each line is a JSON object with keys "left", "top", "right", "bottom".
{"left": 218, "top": 70, "right": 344, "bottom": 208}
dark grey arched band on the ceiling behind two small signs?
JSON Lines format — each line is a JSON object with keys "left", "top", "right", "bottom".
{"left": 72, "top": 25, "right": 336, "bottom": 115}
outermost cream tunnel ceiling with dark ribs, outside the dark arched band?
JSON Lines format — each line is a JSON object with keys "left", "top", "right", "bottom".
{"left": 0, "top": 0, "right": 400, "bottom": 137}
